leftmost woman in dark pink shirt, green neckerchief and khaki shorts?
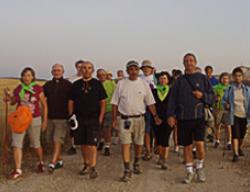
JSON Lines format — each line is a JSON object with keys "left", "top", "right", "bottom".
{"left": 5, "top": 67, "right": 47, "bottom": 179}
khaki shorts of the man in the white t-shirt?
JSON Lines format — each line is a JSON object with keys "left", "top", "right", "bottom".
{"left": 119, "top": 116, "right": 145, "bottom": 145}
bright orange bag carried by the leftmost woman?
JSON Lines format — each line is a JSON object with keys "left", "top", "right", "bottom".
{"left": 8, "top": 105, "right": 32, "bottom": 133}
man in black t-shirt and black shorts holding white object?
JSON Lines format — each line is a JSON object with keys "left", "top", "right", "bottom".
{"left": 68, "top": 61, "right": 107, "bottom": 179}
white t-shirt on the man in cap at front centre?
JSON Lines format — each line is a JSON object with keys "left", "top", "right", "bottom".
{"left": 111, "top": 78, "right": 155, "bottom": 115}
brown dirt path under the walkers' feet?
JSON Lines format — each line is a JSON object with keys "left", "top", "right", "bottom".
{"left": 0, "top": 146, "right": 250, "bottom": 192}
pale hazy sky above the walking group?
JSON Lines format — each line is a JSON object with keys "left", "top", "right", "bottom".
{"left": 0, "top": 0, "right": 250, "bottom": 78}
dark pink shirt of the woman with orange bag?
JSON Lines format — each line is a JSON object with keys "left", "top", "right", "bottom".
{"left": 14, "top": 85, "right": 43, "bottom": 117}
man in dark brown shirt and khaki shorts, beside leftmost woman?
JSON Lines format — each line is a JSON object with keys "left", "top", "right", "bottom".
{"left": 43, "top": 64, "right": 71, "bottom": 172}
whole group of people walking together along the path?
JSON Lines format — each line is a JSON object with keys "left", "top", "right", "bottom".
{"left": 4, "top": 53, "right": 250, "bottom": 184}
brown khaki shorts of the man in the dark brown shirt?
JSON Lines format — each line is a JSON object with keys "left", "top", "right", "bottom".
{"left": 45, "top": 119, "right": 68, "bottom": 144}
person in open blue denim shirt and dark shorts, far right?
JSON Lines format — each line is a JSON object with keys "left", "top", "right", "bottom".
{"left": 222, "top": 67, "right": 250, "bottom": 162}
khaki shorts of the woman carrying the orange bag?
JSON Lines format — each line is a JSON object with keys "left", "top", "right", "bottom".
{"left": 11, "top": 117, "right": 42, "bottom": 148}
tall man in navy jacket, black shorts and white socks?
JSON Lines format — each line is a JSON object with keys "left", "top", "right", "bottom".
{"left": 167, "top": 53, "right": 214, "bottom": 184}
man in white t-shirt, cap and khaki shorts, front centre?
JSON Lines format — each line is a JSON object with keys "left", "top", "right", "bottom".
{"left": 111, "top": 61, "right": 161, "bottom": 182}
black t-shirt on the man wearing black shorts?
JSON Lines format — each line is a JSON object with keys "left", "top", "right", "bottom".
{"left": 70, "top": 78, "right": 107, "bottom": 118}
